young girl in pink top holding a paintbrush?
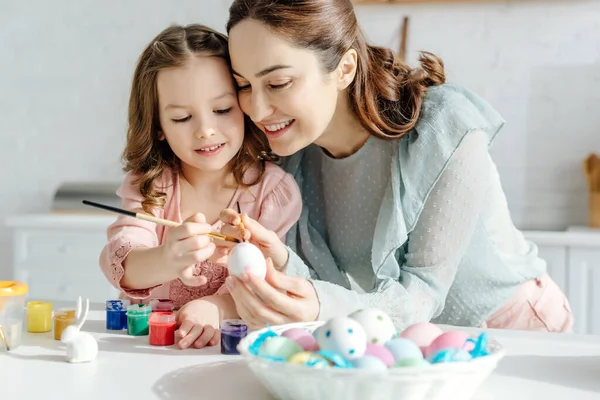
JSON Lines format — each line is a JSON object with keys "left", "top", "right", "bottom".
{"left": 100, "top": 25, "right": 301, "bottom": 348}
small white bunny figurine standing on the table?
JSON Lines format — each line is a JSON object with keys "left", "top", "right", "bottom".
{"left": 60, "top": 296, "right": 98, "bottom": 363}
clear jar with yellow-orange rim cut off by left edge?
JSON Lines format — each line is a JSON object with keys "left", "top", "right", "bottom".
{"left": 0, "top": 281, "right": 29, "bottom": 351}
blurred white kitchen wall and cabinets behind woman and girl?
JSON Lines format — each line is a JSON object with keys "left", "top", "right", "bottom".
{"left": 0, "top": 0, "right": 600, "bottom": 333}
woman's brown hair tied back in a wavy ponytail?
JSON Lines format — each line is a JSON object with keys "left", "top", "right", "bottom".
{"left": 227, "top": 0, "right": 445, "bottom": 139}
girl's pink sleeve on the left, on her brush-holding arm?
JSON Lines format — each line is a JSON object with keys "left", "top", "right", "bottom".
{"left": 100, "top": 173, "right": 164, "bottom": 299}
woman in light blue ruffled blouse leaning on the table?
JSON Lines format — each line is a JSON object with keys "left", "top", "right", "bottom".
{"left": 221, "top": 0, "right": 573, "bottom": 331}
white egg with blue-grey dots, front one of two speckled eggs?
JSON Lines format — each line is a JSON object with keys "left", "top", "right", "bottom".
{"left": 317, "top": 317, "right": 367, "bottom": 360}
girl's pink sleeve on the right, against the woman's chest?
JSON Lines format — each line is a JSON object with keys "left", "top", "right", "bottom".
{"left": 258, "top": 167, "right": 302, "bottom": 240}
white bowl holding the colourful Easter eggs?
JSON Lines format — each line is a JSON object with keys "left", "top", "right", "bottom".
{"left": 238, "top": 321, "right": 505, "bottom": 400}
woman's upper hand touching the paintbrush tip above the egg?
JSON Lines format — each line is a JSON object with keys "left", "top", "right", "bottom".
{"left": 218, "top": 209, "right": 289, "bottom": 270}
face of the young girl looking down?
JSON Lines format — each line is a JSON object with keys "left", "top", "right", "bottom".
{"left": 156, "top": 56, "right": 244, "bottom": 172}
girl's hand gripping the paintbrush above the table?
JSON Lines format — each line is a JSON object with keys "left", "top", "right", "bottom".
{"left": 162, "top": 213, "right": 215, "bottom": 286}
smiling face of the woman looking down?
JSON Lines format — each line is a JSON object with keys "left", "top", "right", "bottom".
{"left": 229, "top": 19, "right": 347, "bottom": 156}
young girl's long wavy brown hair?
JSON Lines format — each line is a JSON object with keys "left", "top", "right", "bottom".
{"left": 122, "top": 25, "right": 269, "bottom": 213}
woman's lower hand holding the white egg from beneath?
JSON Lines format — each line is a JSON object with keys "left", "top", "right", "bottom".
{"left": 225, "top": 259, "right": 320, "bottom": 328}
